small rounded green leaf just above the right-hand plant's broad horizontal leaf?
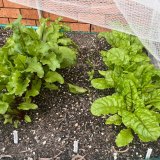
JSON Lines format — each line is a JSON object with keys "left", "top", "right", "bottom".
{"left": 91, "top": 78, "right": 111, "bottom": 89}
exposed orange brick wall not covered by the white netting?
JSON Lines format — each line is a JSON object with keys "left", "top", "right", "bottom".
{"left": 0, "top": 0, "right": 110, "bottom": 32}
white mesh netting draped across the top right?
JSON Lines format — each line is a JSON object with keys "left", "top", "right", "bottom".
{"left": 10, "top": 0, "right": 160, "bottom": 67}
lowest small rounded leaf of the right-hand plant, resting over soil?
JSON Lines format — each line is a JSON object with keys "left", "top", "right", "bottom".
{"left": 116, "top": 129, "right": 133, "bottom": 147}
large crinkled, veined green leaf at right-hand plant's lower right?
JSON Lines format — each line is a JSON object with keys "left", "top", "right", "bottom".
{"left": 122, "top": 108, "right": 160, "bottom": 142}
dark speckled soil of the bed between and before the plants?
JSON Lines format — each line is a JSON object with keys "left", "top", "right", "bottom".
{"left": 0, "top": 31, "right": 160, "bottom": 160}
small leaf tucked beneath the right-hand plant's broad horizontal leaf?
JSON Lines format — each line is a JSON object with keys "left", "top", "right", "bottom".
{"left": 105, "top": 114, "right": 122, "bottom": 125}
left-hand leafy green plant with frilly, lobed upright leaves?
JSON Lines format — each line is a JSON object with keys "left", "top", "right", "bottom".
{"left": 0, "top": 16, "right": 77, "bottom": 127}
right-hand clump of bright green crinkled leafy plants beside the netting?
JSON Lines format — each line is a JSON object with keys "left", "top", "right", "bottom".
{"left": 91, "top": 31, "right": 160, "bottom": 147}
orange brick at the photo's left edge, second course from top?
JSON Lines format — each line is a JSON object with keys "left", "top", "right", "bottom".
{"left": 0, "top": 8, "right": 20, "bottom": 18}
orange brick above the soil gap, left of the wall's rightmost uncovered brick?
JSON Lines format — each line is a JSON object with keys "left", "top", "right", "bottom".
{"left": 65, "top": 23, "right": 90, "bottom": 32}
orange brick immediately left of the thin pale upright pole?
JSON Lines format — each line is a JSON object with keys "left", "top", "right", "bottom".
{"left": 21, "top": 9, "right": 39, "bottom": 19}
